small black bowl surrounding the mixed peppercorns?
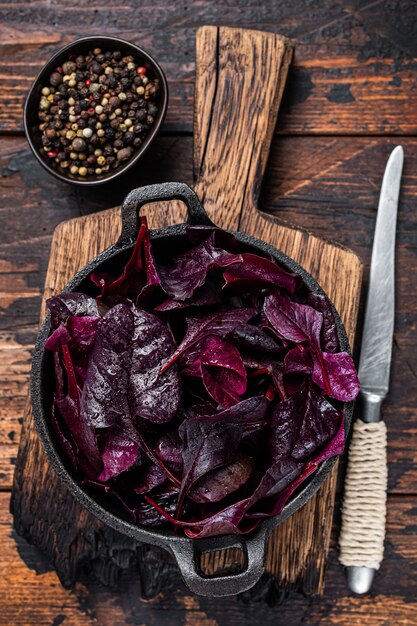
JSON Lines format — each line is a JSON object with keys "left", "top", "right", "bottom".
{"left": 23, "top": 37, "right": 168, "bottom": 187}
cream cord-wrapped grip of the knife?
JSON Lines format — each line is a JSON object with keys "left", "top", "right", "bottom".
{"left": 339, "top": 419, "right": 388, "bottom": 570}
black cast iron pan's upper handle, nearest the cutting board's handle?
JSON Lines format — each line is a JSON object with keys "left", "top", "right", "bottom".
{"left": 117, "top": 183, "right": 214, "bottom": 245}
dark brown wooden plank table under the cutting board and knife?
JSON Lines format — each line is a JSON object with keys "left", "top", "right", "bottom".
{"left": 0, "top": 0, "right": 417, "bottom": 626}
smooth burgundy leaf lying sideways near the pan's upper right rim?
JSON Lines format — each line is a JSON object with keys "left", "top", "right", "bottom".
{"left": 223, "top": 253, "right": 300, "bottom": 294}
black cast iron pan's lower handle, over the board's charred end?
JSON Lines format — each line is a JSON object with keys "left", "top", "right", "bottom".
{"left": 169, "top": 527, "right": 269, "bottom": 598}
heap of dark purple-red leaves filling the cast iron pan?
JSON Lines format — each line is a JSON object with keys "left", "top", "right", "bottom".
{"left": 46, "top": 218, "right": 359, "bottom": 537}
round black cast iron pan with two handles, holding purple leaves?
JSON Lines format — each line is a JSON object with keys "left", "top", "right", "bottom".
{"left": 32, "top": 183, "right": 353, "bottom": 597}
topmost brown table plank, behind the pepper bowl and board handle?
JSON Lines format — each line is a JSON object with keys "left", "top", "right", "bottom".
{"left": 0, "top": 0, "right": 417, "bottom": 135}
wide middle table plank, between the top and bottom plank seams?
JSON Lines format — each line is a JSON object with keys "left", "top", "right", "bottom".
{"left": 0, "top": 137, "right": 417, "bottom": 494}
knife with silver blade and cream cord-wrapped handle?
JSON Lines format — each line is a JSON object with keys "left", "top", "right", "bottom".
{"left": 339, "top": 146, "right": 404, "bottom": 593}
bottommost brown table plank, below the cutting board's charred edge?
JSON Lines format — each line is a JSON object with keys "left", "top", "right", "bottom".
{"left": 0, "top": 493, "right": 417, "bottom": 626}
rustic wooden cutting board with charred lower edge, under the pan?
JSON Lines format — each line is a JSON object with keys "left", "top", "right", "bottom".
{"left": 12, "top": 26, "right": 362, "bottom": 594}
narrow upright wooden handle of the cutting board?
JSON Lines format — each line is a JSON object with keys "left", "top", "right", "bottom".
{"left": 194, "top": 26, "right": 293, "bottom": 230}
